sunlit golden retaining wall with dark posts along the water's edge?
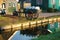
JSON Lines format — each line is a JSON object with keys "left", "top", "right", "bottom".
{"left": 2, "top": 17, "right": 60, "bottom": 31}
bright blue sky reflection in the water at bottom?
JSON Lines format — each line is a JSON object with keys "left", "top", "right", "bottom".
{"left": 11, "top": 31, "right": 37, "bottom": 40}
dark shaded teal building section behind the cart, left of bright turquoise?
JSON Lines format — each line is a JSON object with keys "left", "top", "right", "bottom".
{"left": 31, "top": 0, "right": 49, "bottom": 10}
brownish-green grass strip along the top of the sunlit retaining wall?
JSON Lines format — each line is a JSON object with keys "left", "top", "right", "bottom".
{"left": 0, "top": 15, "right": 60, "bottom": 27}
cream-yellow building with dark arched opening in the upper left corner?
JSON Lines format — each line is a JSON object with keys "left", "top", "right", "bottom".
{"left": 0, "top": 0, "right": 17, "bottom": 13}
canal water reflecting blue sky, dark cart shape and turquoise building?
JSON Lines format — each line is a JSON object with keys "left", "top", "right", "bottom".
{"left": 7, "top": 22, "right": 60, "bottom": 40}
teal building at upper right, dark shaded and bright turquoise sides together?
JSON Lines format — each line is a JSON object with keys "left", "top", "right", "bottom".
{"left": 31, "top": 0, "right": 60, "bottom": 11}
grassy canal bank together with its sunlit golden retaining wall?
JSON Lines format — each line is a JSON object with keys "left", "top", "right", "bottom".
{"left": 0, "top": 15, "right": 60, "bottom": 31}
